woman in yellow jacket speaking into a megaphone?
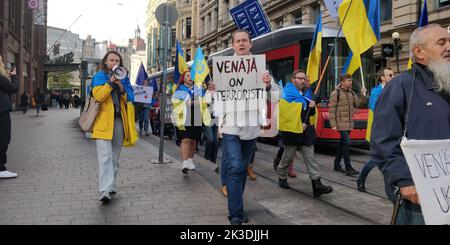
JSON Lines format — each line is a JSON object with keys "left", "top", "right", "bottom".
{"left": 92, "top": 51, "right": 138, "bottom": 202}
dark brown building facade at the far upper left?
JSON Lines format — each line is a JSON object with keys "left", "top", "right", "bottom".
{"left": 0, "top": 0, "right": 47, "bottom": 106}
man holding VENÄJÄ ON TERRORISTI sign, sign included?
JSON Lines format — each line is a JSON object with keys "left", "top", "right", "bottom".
{"left": 213, "top": 30, "right": 274, "bottom": 225}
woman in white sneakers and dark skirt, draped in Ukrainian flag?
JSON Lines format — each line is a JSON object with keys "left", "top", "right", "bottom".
{"left": 172, "top": 71, "right": 211, "bottom": 174}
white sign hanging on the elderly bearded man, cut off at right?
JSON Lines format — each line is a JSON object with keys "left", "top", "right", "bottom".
{"left": 401, "top": 139, "right": 450, "bottom": 225}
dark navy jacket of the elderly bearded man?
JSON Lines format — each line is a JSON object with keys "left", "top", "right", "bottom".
{"left": 370, "top": 64, "right": 450, "bottom": 201}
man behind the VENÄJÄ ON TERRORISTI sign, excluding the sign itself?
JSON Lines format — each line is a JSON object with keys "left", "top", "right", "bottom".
{"left": 212, "top": 30, "right": 272, "bottom": 225}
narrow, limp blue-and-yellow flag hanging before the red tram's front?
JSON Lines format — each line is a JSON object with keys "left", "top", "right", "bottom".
{"left": 306, "top": 15, "right": 322, "bottom": 84}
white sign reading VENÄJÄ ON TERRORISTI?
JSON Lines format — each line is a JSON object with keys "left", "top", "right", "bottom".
{"left": 213, "top": 55, "right": 266, "bottom": 115}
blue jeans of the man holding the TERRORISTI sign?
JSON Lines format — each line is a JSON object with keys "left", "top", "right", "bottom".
{"left": 222, "top": 134, "right": 256, "bottom": 220}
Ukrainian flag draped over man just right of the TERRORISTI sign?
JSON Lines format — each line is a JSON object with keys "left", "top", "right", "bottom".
{"left": 278, "top": 83, "right": 305, "bottom": 134}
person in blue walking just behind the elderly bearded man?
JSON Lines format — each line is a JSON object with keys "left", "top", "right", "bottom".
{"left": 356, "top": 68, "right": 395, "bottom": 192}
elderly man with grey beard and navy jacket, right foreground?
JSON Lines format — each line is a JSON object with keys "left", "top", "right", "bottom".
{"left": 370, "top": 24, "right": 450, "bottom": 225}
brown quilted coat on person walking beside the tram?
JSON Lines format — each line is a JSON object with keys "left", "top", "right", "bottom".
{"left": 329, "top": 87, "right": 357, "bottom": 131}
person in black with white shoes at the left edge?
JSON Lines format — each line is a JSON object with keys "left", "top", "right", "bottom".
{"left": 0, "top": 56, "right": 19, "bottom": 179}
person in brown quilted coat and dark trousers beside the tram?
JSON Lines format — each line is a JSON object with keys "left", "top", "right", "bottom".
{"left": 329, "top": 74, "right": 359, "bottom": 176}
